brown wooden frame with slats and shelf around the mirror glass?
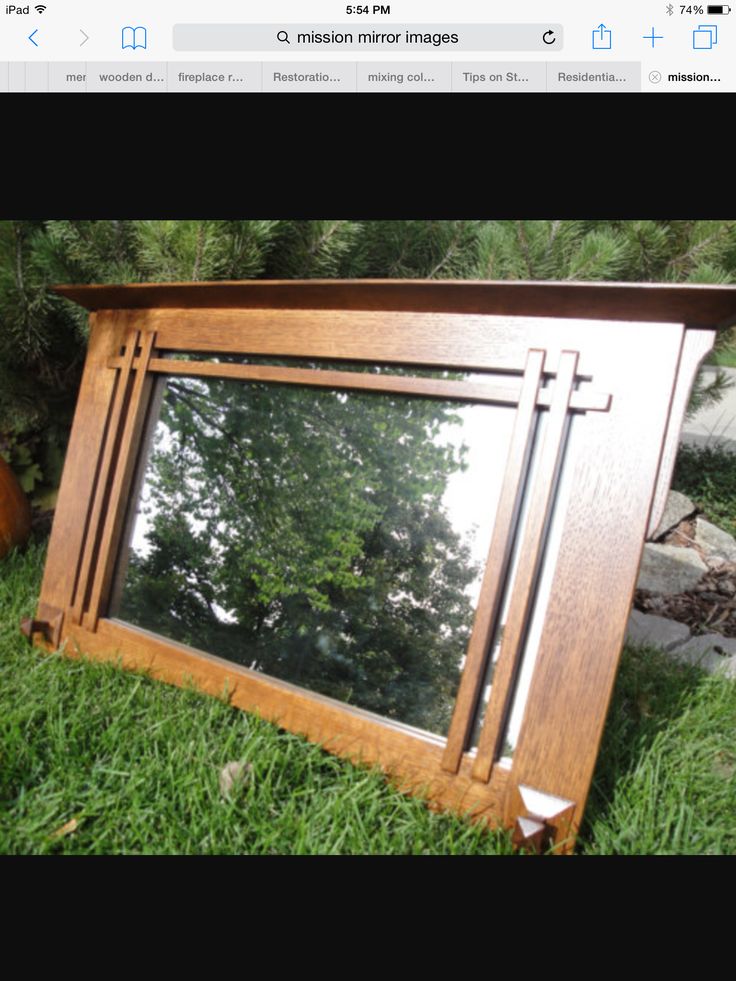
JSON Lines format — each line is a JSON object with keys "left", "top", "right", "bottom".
{"left": 25, "top": 281, "right": 736, "bottom": 851}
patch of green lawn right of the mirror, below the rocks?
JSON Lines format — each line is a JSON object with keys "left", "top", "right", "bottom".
{"left": 579, "top": 650, "right": 736, "bottom": 855}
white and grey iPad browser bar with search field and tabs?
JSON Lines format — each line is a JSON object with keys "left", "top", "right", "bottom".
{"left": 0, "top": 0, "right": 736, "bottom": 93}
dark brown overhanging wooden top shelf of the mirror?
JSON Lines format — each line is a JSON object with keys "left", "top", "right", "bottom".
{"left": 54, "top": 279, "right": 736, "bottom": 329}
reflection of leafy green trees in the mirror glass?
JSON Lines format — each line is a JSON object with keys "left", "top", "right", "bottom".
{"left": 113, "top": 378, "right": 479, "bottom": 734}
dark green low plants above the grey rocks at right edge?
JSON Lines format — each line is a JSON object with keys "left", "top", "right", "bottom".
{"left": 672, "top": 446, "right": 736, "bottom": 535}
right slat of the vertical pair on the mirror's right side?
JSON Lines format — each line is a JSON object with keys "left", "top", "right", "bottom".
{"left": 473, "top": 351, "right": 578, "bottom": 781}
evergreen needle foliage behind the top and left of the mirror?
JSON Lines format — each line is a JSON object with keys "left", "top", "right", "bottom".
{"left": 0, "top": 220, "right": 736, "bottom": 506}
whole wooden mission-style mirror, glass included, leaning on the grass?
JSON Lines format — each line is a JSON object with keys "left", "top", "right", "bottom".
{"left": 26, "top": 280, "right": 736, "bottom": 851}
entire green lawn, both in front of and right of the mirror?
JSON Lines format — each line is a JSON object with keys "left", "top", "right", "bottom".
{"left": 0, "top": 545, "right": 736, "bottom": 855}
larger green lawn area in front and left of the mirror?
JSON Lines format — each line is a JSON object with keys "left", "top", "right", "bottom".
{"left": 0, "top": 546, "right": 510, "bottom": 855}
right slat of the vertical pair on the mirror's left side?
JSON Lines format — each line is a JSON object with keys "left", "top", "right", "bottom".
{"left": 83, "top": 333, "right": 155, "bottom": 630}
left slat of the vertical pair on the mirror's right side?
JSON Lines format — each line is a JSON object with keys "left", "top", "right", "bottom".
{"left": 442, "top": 350, "right": 545, "bottom": 773}
